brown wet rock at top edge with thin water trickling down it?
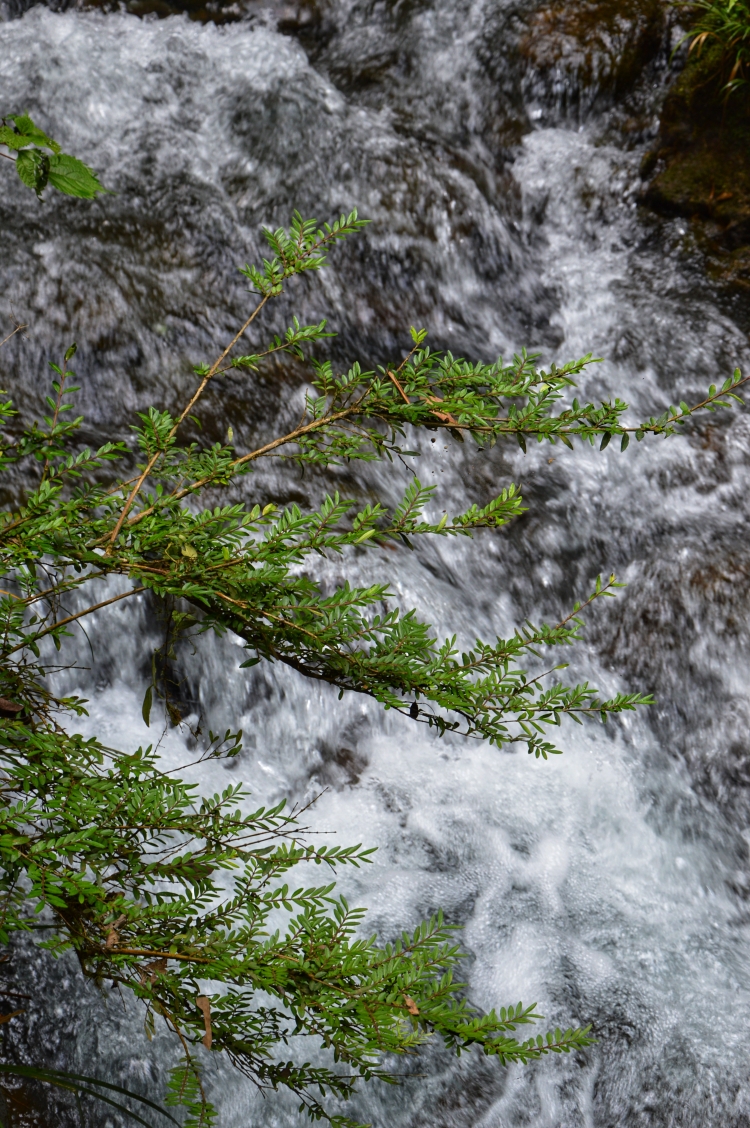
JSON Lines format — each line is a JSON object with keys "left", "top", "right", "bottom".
{"left": 520, "top": 0, "right": 667, "bottom": 95}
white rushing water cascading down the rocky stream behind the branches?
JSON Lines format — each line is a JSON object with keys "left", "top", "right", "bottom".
{"left": 0, "top": 0, "right": 750, "bottom": 1128}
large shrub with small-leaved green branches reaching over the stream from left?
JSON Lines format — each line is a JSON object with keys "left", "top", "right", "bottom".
{"left": 0, "top": 129, "right": 744, "bottom": 1128}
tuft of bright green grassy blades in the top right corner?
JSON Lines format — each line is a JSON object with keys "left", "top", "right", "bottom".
{"left": 673, "top": 0, "right": 750, "bottom": 97}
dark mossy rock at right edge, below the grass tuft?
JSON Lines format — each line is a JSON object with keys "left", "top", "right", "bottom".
{"left": 642, "top": 49, "right": 750, "bottom": 250}
